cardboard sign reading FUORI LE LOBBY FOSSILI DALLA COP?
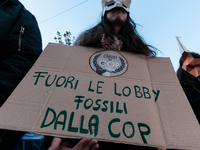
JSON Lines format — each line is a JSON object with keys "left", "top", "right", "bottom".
{"left": 0, "top": 44, "right": 200, "bottom": 149}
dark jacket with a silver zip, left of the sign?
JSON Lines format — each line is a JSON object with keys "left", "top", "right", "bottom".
{"left": 0, "top": 0, "right": 42, "bottom": 149}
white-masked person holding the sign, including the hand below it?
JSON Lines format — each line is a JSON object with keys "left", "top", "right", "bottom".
{"left": 49, "top": 0, "right": 166, "bottom": 150}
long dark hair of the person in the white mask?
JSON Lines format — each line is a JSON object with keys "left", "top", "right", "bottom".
{"left": 74, "top": 13, "right": 157, "bottom": 56}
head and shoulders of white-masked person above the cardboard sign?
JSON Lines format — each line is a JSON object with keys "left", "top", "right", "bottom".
{"left": 74, "top": 0, "right": 156, "bottom": 56}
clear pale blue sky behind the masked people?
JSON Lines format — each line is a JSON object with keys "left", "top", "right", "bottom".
{"left": 20, "top": 0, "right": 200, "bottom": 70}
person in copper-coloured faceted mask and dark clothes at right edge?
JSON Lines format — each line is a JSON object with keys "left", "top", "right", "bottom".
{"left": 177, "top": 52, "right": 200, "bottom": 123}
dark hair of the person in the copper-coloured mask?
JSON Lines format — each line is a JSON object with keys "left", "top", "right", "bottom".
{"left": 176, "top": 52, "right": 200, "bottom": 92}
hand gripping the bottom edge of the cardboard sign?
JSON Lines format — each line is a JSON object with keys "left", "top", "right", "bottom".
{"left": 48, "top": 137, "right": 99, "bottom": 150}
